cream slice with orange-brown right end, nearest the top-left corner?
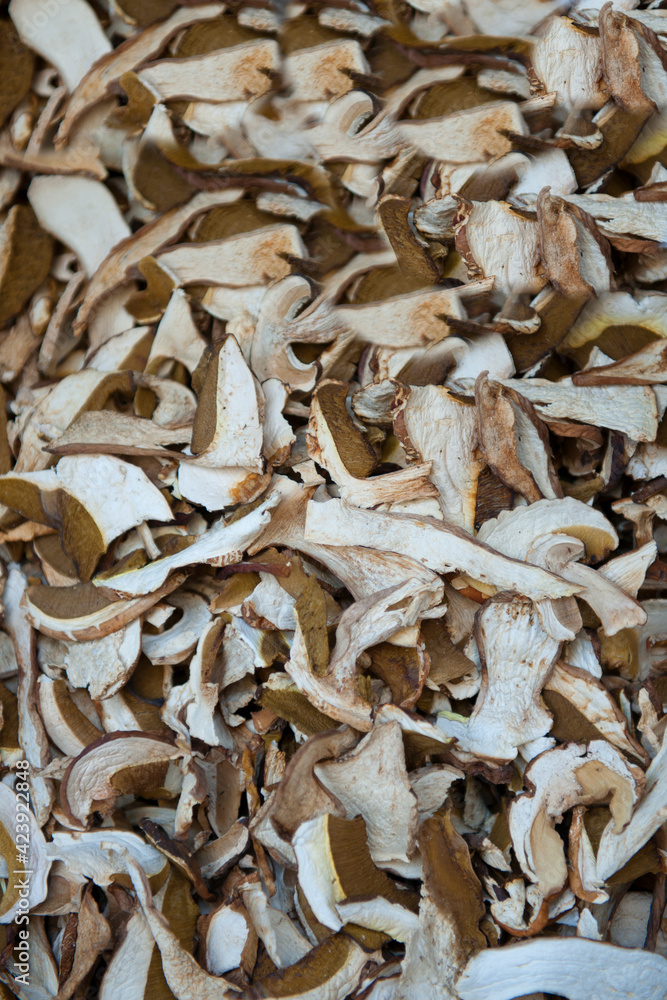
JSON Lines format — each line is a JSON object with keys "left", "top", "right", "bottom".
{"left": 138, "top": 38, "right": 280, "bottom": 101}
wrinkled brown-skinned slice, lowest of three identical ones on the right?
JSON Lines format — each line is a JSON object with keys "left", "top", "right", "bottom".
{"left": 475, "top": 375, "right": 562, "bottom": 503}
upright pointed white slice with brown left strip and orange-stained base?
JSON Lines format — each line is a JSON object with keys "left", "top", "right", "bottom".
{"left": 178, "top": 337, "right": 268, "bottom": 510}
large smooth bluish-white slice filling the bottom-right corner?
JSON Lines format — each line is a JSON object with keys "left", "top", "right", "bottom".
{"left": 456, "top": 937, "right": 667, "bottom": 1000}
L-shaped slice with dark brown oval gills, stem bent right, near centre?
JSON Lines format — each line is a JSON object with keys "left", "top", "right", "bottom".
{"left": 306, "top": 379, "right": 435, "bottom": 507}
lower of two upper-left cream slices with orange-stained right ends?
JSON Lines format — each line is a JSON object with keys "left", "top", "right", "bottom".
{"left": 157, "top": 225, "right": 307, "bottom": 288}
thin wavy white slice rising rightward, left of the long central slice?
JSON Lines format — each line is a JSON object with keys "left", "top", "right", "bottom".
{"left": 93, "top": 494, "right": 279, "bottom": 597}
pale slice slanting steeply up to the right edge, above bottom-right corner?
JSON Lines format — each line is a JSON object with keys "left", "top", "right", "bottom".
{"left": 597, "top": 739, "right": 667, "bottom": 879}
